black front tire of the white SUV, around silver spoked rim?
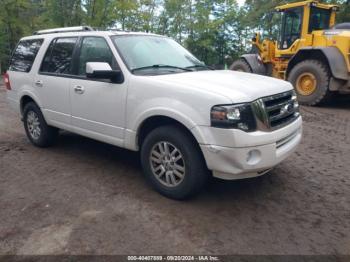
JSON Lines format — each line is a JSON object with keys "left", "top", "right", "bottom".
{"left": 141, "top": 125, "right": 209, "bottom": 200}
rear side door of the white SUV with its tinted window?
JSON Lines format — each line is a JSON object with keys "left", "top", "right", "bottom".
{"left": 34, "top": 37, "right": 78, "bottom": 129}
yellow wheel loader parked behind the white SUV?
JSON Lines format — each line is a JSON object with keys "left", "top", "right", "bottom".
{"left": 230, "top": 0, "right": 350, "bottom": 106}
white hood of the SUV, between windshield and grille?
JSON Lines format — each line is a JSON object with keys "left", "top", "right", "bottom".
{"left": 153, "top": 70, "right": 293, "bottom": 103}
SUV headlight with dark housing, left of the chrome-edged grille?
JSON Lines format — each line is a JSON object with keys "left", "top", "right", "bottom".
{"left": 211, "top": 104, "right": 256, "bottom": 132}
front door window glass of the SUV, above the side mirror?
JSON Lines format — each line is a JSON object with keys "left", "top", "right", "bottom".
{"left": 78, "top": 37, "right": 117, "bottom": 75}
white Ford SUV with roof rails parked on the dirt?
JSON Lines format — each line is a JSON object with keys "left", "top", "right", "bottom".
{"left": 4, "top": 27, "right": 302, "bottom": 199}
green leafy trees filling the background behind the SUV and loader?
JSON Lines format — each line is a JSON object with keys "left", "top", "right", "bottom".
{"left": 0, "top": 0, "right": 350, "bottom": 71}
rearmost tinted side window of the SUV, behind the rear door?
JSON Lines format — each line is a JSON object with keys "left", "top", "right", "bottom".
{"left": 9, "top": 39, "right": 43, "bottom": 72}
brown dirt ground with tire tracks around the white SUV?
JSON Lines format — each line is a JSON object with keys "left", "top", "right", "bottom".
{"left": 0, "top": 87, "right": 350, "bottom": 255}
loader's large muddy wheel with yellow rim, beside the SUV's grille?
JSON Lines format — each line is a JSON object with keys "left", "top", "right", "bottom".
{"left": 288, "top": 60, "right": 331, "bottom": 106}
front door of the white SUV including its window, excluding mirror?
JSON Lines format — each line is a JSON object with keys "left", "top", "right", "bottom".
{"left": 70, "top": 36, "right": 127, "bottom": 146}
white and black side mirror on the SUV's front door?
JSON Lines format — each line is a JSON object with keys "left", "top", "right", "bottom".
{"left": 86, "top": 62, "right": 124, "bottom": 84}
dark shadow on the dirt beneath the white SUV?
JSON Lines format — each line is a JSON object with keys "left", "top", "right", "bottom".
{"left": 52, "top": 131, "right": 277, "bottom": 201}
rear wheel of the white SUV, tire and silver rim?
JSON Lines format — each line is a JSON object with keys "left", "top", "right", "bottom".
{"left": 23, "top": 102, "right": 58, "bottom": 148}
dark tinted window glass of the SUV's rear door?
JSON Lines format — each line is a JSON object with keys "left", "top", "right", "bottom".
{"left": 40, "top": 37, "right": 78, "bottom": 74}
